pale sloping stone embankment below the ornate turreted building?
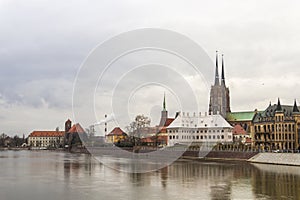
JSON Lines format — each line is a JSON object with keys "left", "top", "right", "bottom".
{"left": 248, "top": 153, "right": 300, "bottom": 166}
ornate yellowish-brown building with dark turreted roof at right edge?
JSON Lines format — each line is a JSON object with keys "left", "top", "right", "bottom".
{"left": 253, "top": 98, "right": 300, "bottom": 150}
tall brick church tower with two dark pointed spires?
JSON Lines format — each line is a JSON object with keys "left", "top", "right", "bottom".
{"left": 208, "top": 51, "right": 231, "bottom": 118}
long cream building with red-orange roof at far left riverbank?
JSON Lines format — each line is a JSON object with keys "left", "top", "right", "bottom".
{"left": 28, "top": 131, "right": 65, "bottom": 148}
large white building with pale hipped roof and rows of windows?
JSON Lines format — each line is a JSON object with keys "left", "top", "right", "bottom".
{"left": 167, "top": 112, "right": 233, "bottom": 146}
